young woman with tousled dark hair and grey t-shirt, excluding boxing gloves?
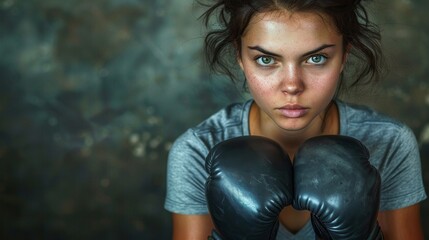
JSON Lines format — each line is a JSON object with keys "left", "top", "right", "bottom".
{"left": 165, "top": 0, "right": 426, "bottom": 239}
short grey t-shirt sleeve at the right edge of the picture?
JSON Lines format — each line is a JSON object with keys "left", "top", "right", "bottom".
{"left": 380, "top": 126, "right": 426, "bottom": 210}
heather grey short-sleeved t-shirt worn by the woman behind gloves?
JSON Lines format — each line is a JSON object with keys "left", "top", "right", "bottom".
{"left": 164, "top": 100, "right": 426, "bottom": 239}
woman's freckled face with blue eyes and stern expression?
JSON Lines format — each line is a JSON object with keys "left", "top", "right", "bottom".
{"left": 238, "top": 10, "right": 346, "bottom": 131}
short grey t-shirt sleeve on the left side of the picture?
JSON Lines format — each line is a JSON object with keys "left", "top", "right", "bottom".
{"left": 164, "top": 130, "right": 208, "bottom": 214}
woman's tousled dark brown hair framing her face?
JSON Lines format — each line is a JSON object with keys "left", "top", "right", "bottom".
{"left": 200, "top": 0, "right": 383, "bottom": 91}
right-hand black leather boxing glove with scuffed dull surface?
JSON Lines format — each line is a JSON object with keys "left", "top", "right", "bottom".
{"left": 293, "top": 136, "right": 383, "bottom": 240}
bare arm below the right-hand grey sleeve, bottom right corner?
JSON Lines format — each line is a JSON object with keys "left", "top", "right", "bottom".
{"left": 378, "top": 204, "right": 423, "bottom": 240}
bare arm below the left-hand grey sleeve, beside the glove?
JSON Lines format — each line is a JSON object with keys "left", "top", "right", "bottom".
{"left": 173, "top": 213, "right": 214, "bottom": 240}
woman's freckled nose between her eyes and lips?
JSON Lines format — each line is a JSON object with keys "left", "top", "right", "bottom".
{"left": 282, "top": 64, "right": 304, "bottom": 95}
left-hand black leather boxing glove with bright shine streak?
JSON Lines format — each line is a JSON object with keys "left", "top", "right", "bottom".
{"left": 206, "top": 136, "right": 293, "bottom": 240}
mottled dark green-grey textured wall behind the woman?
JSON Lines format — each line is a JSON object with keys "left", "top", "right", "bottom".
{"left": 0, "top": 0, "right": 429, "bottom": 239}
